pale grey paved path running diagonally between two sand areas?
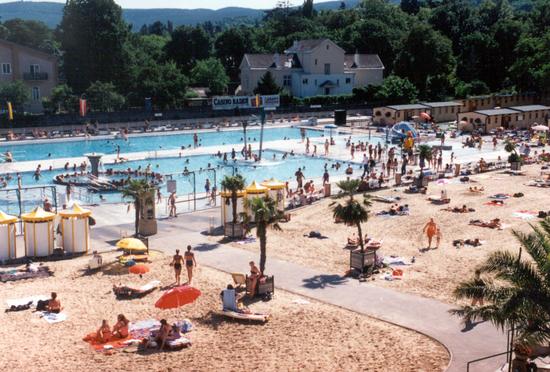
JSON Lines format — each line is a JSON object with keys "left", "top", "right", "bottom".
{"left": 93, "top": 209, "right": 506, "bottom": 371}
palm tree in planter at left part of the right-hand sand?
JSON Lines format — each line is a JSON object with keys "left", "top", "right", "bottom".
{"left": 331, "top": 180, "right": 371, "bottom": 252}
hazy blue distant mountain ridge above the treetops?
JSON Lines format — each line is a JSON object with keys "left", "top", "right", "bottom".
{"left": 0, "top": 0, "right": 361, "bottom": 30}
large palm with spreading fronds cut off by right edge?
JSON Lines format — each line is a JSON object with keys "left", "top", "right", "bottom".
{"left": 451, "top": 218, "right": 550, "bottom": 342}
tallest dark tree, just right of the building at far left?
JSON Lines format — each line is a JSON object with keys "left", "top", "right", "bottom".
{"left": 59, "top": 0, "right": 129, "bottom": 94}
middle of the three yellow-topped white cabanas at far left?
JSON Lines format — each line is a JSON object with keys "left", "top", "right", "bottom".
{"left": 21, "top": 207, "right": 55, "bottom": 257}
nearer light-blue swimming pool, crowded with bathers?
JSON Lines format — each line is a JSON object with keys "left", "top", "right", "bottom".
{"left": 0, "top": 150, "right": 361, "bottom": 209}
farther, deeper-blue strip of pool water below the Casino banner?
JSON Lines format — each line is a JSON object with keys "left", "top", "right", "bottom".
{"left": 0, "top": 127, "right": 323, "bottom": 161}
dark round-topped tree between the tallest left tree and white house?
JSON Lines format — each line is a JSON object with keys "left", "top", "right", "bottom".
{"left": 165, "top": 26, "right": 212, "bottom": 73}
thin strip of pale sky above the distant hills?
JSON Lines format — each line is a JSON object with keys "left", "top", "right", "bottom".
{"left": 0, "top": 0, "right": 327, "bottom": 9}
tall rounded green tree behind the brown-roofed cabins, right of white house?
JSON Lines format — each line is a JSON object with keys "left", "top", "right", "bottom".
{"left": 395, "top": 24, "right": 455, "bottom": 97}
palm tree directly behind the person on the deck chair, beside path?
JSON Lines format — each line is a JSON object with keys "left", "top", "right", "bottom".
{"left": 250, "top": 196, "right": 283, "bottom": 273}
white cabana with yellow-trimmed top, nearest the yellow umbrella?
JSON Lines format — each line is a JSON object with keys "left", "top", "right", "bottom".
{"left": 59, "top": 203, "right": 92, "bottom": 253}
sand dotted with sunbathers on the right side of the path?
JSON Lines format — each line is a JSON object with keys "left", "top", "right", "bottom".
{"left": 218, "top": 165, "right": 550, "bottom": 304}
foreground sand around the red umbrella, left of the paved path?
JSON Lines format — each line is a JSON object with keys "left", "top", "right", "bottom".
{"left": 0, "top": 253, "right": 449, "bottom": 371}
